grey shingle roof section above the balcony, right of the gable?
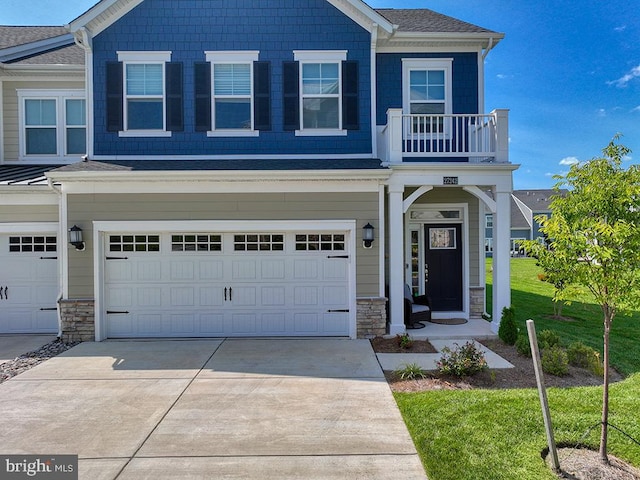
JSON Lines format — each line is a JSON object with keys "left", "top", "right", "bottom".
{"left": 375, "top": 8, "right": 497, "bottom": 33}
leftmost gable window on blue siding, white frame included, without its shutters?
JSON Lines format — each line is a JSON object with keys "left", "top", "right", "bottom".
{"left": 118, "top": 52, "right": 171, "bottom": 132}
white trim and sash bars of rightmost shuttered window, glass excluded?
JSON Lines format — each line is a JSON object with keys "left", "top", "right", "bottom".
{"left": 293, "top": 50, "right": 347, "bottom": 137}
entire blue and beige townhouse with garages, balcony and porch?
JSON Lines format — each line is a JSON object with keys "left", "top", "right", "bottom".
{"left": 0, "top": 0, "right": 517, "bottom": 340}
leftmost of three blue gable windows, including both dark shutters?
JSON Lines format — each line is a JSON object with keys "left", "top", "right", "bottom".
{"left": 106, "top": 52, "right": 184, "bottom": 137}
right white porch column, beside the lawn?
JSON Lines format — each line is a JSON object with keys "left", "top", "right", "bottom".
{"left": 491, "top": 191, "right": 511, "bottom": 332}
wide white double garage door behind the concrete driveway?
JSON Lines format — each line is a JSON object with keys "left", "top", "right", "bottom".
{"left": 104, "top": 232, "right": 350, "bottom": 338}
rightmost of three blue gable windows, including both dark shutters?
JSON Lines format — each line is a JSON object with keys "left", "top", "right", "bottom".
{"left": 283, "top": 50, "right": 359, "bottom": 136}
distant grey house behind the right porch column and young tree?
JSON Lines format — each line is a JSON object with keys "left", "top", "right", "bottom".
{"left": 485, "top": 189, "right": 564, "bottom": 257}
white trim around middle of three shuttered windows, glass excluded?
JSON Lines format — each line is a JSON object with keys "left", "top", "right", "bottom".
{"left": 204, "top": 50, "right": 260, "bottom": 137}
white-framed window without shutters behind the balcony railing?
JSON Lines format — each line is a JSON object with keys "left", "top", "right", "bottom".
{"left": 402, "top": 58, "right": 453, "bottom": 134}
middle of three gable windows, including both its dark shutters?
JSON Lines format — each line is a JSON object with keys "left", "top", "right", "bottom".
{"left": 194, "top": 51, "right": 271, "bottom": 137}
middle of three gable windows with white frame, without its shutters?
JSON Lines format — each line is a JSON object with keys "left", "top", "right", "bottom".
{"left": 204, "top": 51, "right": 262, "bottom": 136}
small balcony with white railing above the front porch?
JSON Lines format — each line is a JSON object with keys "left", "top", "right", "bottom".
{"left": 378, "top": 108, "right": 509, "bottom": 164}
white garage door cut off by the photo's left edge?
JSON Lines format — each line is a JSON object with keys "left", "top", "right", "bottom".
{"left": 0, "top": 233, "right": 58, "bottom": 333}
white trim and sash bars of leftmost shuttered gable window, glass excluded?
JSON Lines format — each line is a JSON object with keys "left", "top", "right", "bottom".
{"left": 116, "top": 51, "right": 172, "bottom": 137}
